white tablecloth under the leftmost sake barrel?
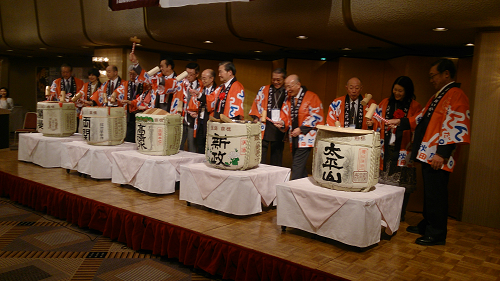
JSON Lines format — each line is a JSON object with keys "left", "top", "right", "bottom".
{"left": 17, "top": 133, "right": 83, "bottom": 168}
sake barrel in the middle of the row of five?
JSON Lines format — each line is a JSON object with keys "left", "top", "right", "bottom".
{"left": 135, "top": 108, "right": 182, "bottom": 155}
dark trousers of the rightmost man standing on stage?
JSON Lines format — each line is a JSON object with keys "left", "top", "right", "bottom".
{"left": 418, "top": 163, "right": 450, "bottom": 240}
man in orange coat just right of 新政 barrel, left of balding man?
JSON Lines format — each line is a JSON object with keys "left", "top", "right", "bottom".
{"left": 249, "top": 68, "right": 286, "bottom": 166}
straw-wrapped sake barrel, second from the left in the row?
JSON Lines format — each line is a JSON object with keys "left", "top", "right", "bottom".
{"left": 81, "top": 107, "right": 127, "bottom": 145}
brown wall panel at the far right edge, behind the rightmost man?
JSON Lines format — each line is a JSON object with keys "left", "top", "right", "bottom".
{"left": 462, "top": 31, "right": 500, "bottom": 228}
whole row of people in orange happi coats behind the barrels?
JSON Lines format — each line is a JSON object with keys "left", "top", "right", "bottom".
{"left": 49, "top": 53, "right": 470, "bottom": 245}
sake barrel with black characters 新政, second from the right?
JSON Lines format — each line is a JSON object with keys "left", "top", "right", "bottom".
{"left": 205, "top": 121, "right": 262, "bottom": 170}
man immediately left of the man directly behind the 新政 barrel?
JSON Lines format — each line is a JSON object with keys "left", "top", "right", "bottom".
{"left": 188, "top": 69, "right": 217, "bottom": 153}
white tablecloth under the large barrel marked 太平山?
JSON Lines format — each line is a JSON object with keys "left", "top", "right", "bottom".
{"left": 276, "top": 178, "right": 404, "bottom": 247}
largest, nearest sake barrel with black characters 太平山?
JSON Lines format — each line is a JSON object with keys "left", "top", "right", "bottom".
{"left": 312, "top": 125, "right": 380, "bottom": 191}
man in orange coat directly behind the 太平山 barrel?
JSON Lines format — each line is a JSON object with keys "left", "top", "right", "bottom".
{"left": 327, "top": 77, "right": 375, "bottom": 130}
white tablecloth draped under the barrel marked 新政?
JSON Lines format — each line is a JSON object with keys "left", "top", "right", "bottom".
{"left": 179, "top": 163, "right": 290, "bottom": 215}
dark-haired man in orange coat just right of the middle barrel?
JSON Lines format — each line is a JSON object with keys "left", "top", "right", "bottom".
{"left": 170, "top": 62, "right": 203, "bottom": 152}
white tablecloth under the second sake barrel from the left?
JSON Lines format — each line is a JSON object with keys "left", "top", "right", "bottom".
{"left": 61, "top": 141, "right": 137, "bottom": 179}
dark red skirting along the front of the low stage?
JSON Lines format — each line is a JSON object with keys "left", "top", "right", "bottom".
{"left": 0, "top": 171, "right": 345, "bottom": 281}
